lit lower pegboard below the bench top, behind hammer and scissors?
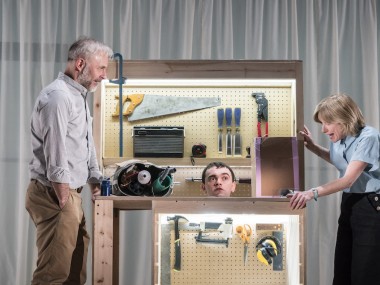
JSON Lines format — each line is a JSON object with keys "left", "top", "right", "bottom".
{"left": 159, "top": 215, "right": 298, "bottom": 285}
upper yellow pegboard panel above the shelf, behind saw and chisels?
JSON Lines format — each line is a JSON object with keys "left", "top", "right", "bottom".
{"left": 101, "top": 79, "right": 296, "bottom": 159}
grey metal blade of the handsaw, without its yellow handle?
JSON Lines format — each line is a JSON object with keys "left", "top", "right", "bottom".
{"left": 128, "top": 94, "right": 221, "bottom": 121}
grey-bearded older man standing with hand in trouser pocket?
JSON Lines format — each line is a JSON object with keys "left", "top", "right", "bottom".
{"left": 25, "top": 38, "right": 113, "bottom": 285}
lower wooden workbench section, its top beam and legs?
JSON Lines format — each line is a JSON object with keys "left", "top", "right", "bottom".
{"left": 93, "top": 196, "right": 306, "bottom": 285}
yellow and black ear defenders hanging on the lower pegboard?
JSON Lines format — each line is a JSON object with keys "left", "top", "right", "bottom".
{"left": 256, "top": 236, "right": 281, "bottom": 265}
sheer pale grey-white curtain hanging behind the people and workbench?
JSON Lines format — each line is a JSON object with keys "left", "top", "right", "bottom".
{"left": 0, "top": 0, "right": 380, "bottom": 285}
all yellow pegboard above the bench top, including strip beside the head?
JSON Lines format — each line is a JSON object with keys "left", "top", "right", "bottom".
{"left": 101, "top": 79, "right": 296, "bottom": 197}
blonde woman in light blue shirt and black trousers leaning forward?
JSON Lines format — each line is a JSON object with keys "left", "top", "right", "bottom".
{"left": 290, "top": 94, "right": 380, "bottom": 285}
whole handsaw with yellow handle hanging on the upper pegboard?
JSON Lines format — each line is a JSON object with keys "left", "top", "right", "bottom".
{"left": 112, "top": 94, "right": 221, "bottom": 121}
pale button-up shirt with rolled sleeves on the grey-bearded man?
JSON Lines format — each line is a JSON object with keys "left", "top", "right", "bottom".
{"left": 29, "top": 73, "right": 102, "bottom": 189}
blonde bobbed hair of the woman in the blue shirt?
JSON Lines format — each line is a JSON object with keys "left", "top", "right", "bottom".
{"left": 313, "top": 93, "right": 365, "bottom": 136}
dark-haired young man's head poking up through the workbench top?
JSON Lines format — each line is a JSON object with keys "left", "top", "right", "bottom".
{"left": 201, "top": 162, "right": 236, "bottom": 197}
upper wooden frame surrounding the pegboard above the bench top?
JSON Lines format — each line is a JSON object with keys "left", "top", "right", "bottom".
{"left": 93, "top": 60, "right": 305, "bottom": 192}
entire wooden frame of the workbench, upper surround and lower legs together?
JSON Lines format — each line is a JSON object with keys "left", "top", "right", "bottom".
{"left": 93, "top": 60, "right": 306, "bottom": 284}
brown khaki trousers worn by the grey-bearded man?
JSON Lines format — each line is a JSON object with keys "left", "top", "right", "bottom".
{"left": 25, "top": 179, "right": 90, "bottom": 285}
